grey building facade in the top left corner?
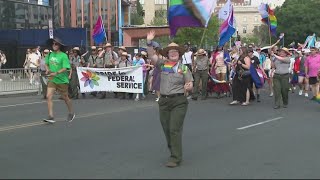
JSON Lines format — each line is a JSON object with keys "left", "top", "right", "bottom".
{"left": 0, "top": 0, "right": 52, "bottom": 29}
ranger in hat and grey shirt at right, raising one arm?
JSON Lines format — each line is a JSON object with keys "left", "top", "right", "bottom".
{"left": 271, "top": 48, "right": 291, "bottom": 109}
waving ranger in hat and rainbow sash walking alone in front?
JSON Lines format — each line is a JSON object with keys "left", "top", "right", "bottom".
{"left": 147, "top": 31, "right": 193, "bottom": 168}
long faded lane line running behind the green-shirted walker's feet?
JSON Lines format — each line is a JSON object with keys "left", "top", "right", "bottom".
{"left": 0, "top": 105, "right": 154, "bottom": 132}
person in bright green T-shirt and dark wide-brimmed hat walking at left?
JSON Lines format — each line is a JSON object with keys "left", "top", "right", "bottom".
{"left": 43, "top": 38, "right": 75, "bottom": 123}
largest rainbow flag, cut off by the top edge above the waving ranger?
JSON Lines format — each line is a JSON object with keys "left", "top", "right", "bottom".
{"left": 168, "top": 0, "right": 217, "bottom": 36}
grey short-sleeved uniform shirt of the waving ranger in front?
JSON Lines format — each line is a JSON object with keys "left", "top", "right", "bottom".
{"left": 157, "top": 60, "right": 193, "bottom": 95}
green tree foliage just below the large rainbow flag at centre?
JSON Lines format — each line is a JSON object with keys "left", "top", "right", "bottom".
{"left": 173, "top": 16, "right": 219, "bottom": 48}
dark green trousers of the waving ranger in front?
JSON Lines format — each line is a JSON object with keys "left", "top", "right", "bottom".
{"left": 158, "top": 96, "right": 188, "bottom": 163}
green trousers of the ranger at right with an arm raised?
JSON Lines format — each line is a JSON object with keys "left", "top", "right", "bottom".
{"left": 273, "top": 74, "right": 290, "bottom": 106}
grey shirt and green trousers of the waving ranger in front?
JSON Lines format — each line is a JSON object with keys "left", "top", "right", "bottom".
{"left": 157, "top": 60, "right": 193, "bottom": 164}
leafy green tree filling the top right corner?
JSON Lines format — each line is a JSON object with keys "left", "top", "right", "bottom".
{"left": 275, "top": 0, "right": 320, "bottom": 45}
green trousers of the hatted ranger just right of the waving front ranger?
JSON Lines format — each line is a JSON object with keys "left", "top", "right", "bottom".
{"left": 193, "top": 70, "right": 208, "bottom": 98}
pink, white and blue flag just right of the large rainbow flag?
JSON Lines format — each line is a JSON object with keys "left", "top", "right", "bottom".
{"left": 219, "top": 6, "right": 236, "bottom": 47}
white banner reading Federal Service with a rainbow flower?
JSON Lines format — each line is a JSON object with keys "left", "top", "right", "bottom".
{"left": 77, "top": 66, "right": 144, "bottom": 93}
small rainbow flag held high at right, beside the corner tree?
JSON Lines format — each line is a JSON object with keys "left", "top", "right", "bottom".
{"left": 259, "top": 3, "right": 278, "bottom": 36}
